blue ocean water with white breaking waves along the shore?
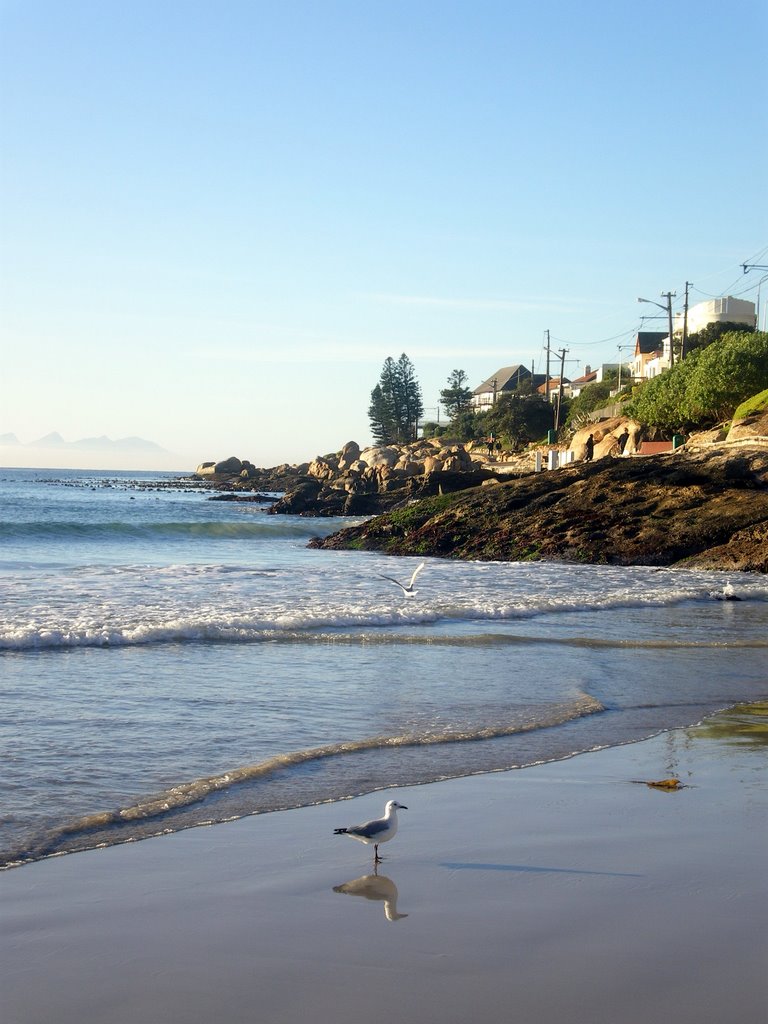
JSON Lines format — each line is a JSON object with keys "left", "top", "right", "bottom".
{"left": 0, "top": 470, "right": 768, "bottom": 867}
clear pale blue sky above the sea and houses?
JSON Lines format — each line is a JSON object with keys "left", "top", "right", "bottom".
{"left": 0, "top": 0, "right": 768, "bottom": 470}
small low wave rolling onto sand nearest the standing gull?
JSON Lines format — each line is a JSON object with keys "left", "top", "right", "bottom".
{"left": 0, "top": 693, "right": 606, "bottom": 867}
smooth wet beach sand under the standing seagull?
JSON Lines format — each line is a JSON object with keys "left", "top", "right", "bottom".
{"left": 0, "top": 716, "right": 768, "bottom": 1024}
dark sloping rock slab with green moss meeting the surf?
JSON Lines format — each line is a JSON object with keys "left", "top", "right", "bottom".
{"left": 311, "top": 441, "right": 768, "bottom": 572}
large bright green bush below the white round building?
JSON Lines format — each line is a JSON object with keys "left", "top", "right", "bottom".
{"left": 625, "top": 330, "right": 768, "bottom": 432}
